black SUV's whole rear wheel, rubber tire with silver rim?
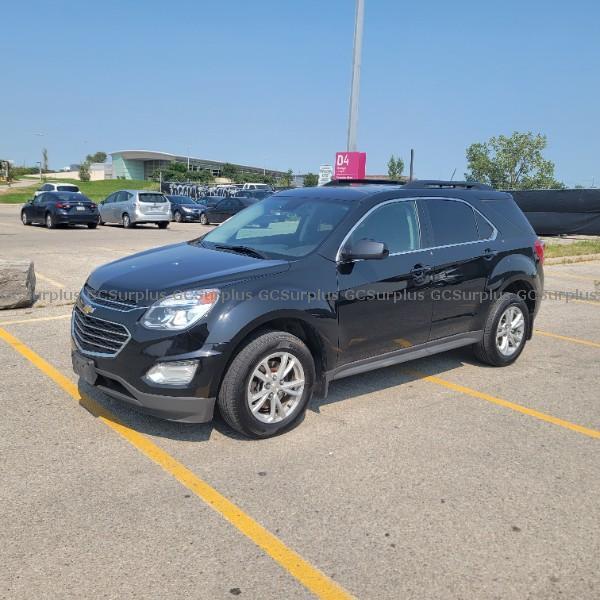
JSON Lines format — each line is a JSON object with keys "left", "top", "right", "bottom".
{"left": 473, "top": 294, "right": 531, "bottom": 367}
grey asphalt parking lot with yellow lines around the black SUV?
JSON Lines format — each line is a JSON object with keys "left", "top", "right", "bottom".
{"left": 0, "top": 205, "right": 600, "bottom": 599}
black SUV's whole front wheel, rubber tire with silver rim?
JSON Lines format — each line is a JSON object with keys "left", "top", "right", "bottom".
{"left": 217, "top": 331, "right": 315, "bottom": 439}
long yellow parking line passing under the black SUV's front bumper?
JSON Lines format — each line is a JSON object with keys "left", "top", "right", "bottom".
{"left": 0, "top": 328, "right": 352, "bottom": 600}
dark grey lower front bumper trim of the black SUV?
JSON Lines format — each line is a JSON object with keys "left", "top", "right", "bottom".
{"left": 71, "top": 349, "right": 215, "bottom": 423}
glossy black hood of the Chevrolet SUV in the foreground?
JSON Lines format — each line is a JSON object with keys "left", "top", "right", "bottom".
{"left": 87, "top": 242, "right": 290, "bottom": 304}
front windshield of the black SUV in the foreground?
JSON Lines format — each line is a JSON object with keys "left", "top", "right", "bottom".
{"left": 201, "top": 196, "right": 349, "bottom": 258}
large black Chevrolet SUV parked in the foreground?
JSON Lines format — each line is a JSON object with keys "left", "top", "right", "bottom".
{"left": 72, "top": 182, "right": 543, "bottom": 437}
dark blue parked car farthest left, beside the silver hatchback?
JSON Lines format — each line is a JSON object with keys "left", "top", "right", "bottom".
{"left": 21, "top": 192, "right": 99, "bottom": 229}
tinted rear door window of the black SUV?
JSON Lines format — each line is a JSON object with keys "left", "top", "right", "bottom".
{"left": 426, "top": 198, "right": 479, "bottom": 246}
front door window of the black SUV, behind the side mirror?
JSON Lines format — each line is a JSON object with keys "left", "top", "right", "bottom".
{"left": 348, "top": 202, "right": 420, "bottom": 254}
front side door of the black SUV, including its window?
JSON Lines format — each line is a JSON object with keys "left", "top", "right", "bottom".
{"left": 337, "top": 200, "right": 432, "bottom": 365}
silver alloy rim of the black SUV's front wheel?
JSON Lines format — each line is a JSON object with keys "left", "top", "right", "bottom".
{"left": 246, "top": 352, "right": 305, "bottom": 423}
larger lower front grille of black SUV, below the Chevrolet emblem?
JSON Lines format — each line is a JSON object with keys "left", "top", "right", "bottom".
{"left": 73, "top": 306, "right": 130, "bottom": 356}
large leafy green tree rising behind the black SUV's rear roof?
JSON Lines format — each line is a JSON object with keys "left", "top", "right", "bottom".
{"left": 465, "top": 131, "right": 565, "bottom": 190}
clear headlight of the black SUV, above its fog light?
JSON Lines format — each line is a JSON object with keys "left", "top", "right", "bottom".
{"left": 142, "top": 290, "right": 219, "bottom": 331}
